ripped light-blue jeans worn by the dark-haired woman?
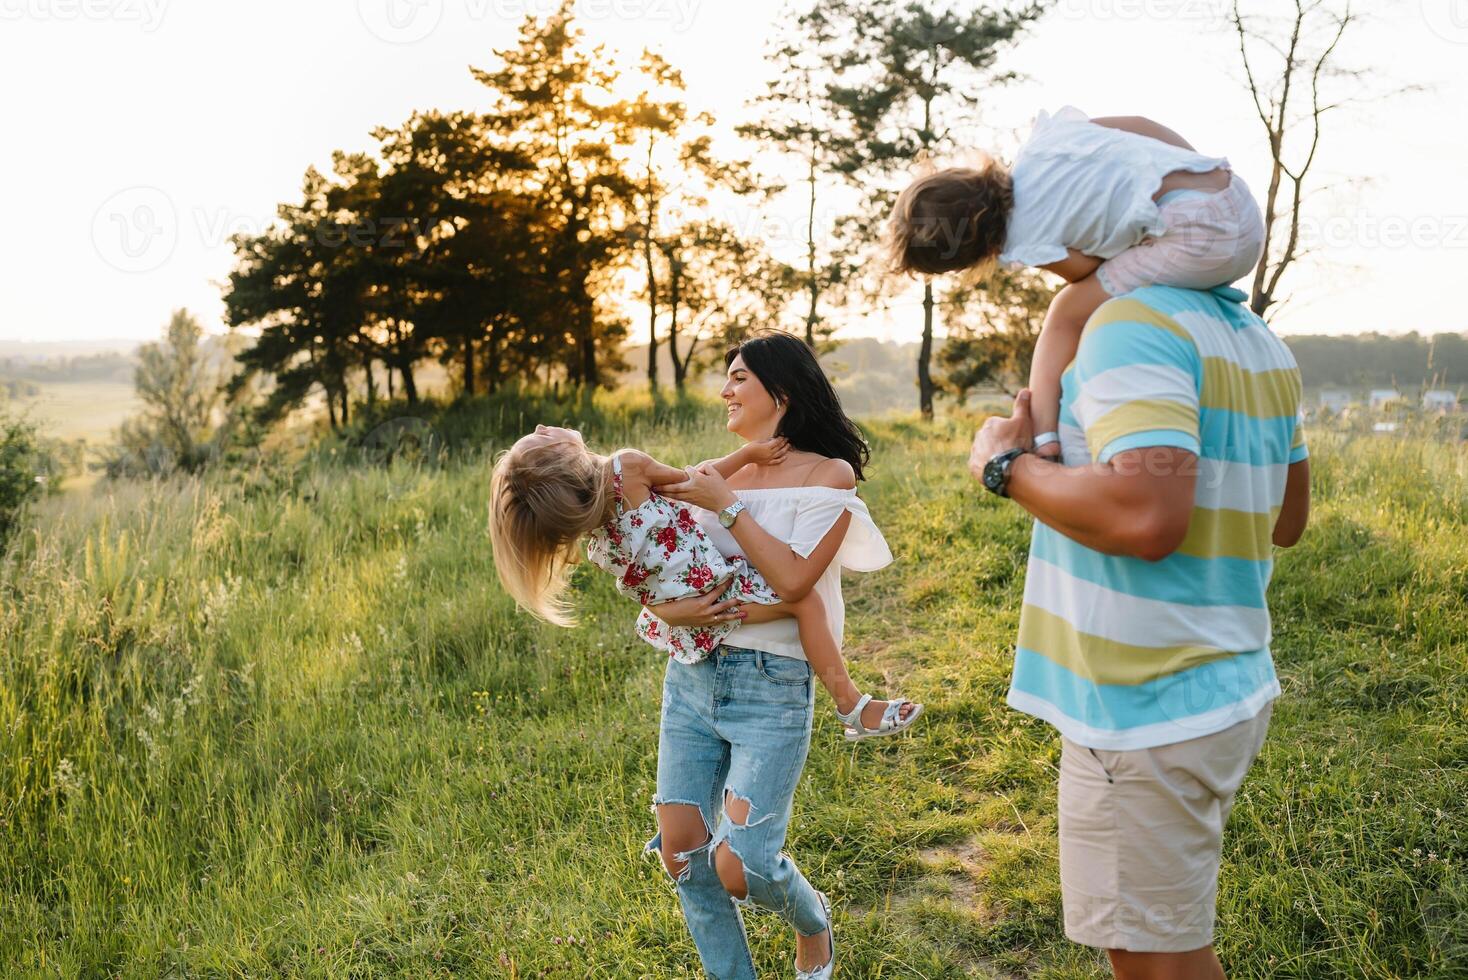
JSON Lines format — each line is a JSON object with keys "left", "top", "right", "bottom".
{"left": 646, "top": 646, "right": 826, "bottom": 980}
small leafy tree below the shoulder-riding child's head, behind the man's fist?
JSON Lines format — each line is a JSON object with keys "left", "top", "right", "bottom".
{"left": 938, "top": 268, "right": 1060, "bottom": 405}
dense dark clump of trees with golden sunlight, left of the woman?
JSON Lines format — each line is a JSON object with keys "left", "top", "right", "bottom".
{"left": 225, "top": 98, "right": 575, "bottom": 427}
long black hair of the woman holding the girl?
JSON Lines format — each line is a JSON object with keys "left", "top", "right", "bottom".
{"left": 724, "top": 330, "right": 872, "bottom": 480}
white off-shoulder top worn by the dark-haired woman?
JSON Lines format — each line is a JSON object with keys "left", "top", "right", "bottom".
{"left": 693, "top": 487, "right": 893, "bottom": 660}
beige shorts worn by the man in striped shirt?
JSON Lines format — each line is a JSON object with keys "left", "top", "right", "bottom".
{"left": 1060, "top": 701, "right": 1274, "bottom": 952}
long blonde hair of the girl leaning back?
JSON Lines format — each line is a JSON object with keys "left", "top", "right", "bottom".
{"left": 489, "top": 443, "right": 612, "bottom": 626}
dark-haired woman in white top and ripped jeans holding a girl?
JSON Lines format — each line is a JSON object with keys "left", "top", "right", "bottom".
{"left": 646, "top": 333, "right": 920, "bottom": 980}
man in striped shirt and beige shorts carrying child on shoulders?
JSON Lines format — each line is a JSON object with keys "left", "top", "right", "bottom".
{"left": 969, "top": 286, "right": 1309, "bottom": 979}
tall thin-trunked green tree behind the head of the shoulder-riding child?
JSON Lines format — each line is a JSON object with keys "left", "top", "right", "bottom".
{"left": 829, "top": 0, "right": 1044, "bottom": 418}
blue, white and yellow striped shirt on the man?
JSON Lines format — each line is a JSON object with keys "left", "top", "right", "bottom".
{"left": 1009, "top": 286, "right": 1307, "bottom": 750}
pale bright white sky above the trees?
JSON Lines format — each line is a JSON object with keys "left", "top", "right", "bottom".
{"left": 0, "top": 0, "right": 1468, "bottom": 342}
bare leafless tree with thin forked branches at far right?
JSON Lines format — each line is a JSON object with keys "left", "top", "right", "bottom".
{"left": 1229, "top": 0, "right": 1408, "bottom": 315}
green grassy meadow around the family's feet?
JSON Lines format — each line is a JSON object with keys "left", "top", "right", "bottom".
{"left": 0, "top": 393, "right": 1468, "bottom": 980}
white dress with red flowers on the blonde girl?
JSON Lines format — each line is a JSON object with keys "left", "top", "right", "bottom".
{"left": 586, "top": 456, "right": 780, "bottom": 663}
